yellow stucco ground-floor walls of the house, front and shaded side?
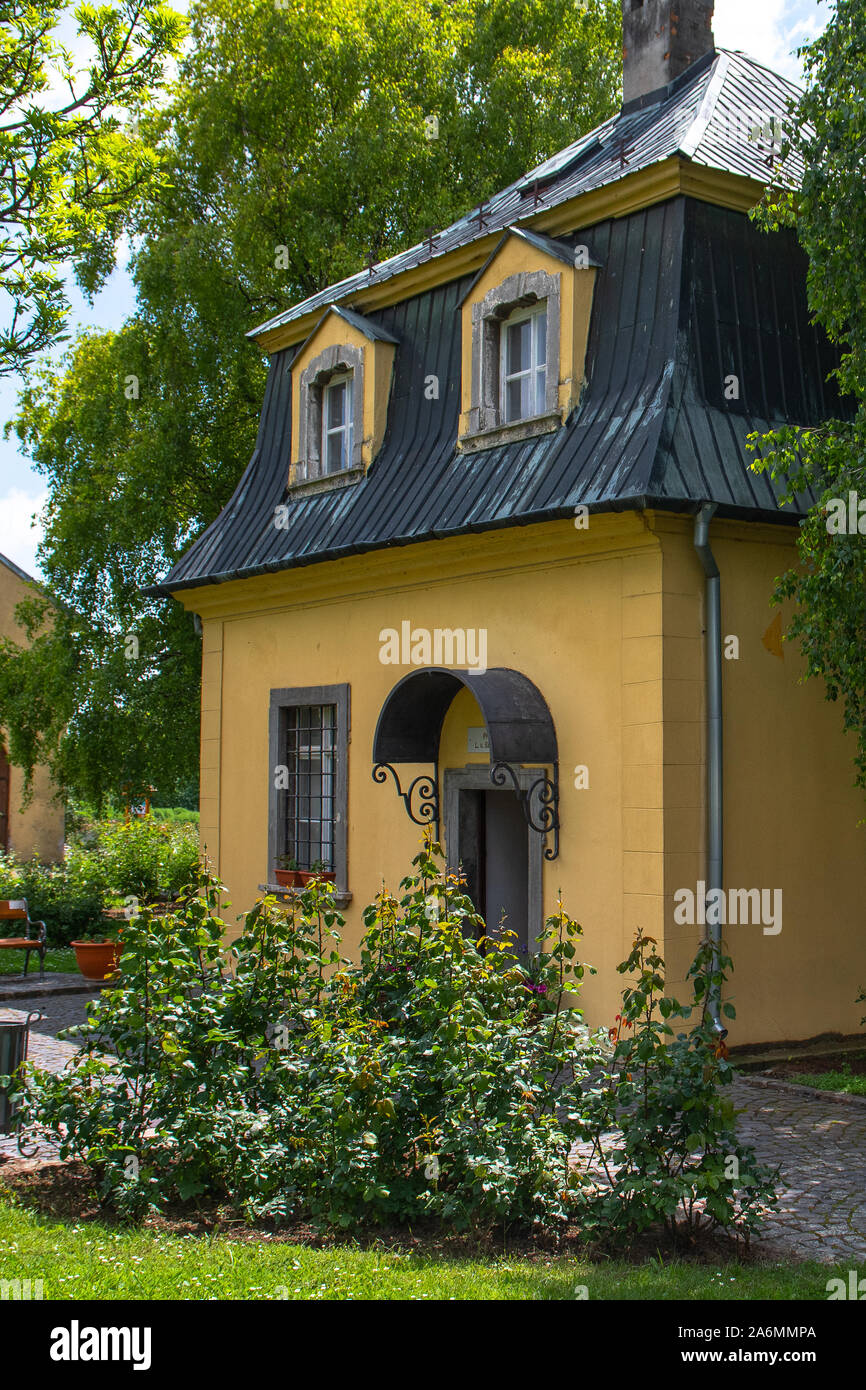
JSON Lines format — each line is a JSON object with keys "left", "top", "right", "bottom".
{"left": 178, "top": 513, "right": 866, "bottom": 1044}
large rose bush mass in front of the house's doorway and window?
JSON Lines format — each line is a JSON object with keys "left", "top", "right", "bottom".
{"left": 22, "top": 849, "right": 596, "bottom": 1226}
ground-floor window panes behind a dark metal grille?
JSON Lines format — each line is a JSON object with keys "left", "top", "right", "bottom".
{"left": 284, "top": 705, "right": 336, "bottom": 869}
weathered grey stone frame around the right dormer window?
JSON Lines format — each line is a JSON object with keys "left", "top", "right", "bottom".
{"left": 460, "top": 270, "right": 562, "bottom": 449}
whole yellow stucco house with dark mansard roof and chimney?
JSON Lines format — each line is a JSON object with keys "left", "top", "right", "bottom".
{"left": 154, "top": 0, "right": 866, "bottom": 1044}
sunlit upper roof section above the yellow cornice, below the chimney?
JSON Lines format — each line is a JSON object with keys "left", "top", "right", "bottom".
{"left": 247, "top": 50, "right": 802, "bottom": 338}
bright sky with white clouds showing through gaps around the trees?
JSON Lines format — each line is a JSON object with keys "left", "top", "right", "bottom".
{"left": 0, "top": 0, "right": 828, "bottom": 575}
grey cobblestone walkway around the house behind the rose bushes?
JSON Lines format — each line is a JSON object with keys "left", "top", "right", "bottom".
{"left": 0, "top": 994, "right": 866, "bottom": 1268}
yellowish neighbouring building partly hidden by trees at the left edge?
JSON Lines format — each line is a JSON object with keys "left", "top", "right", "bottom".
{"left": 0, "top": 555, "right": 64, "bottom": 863}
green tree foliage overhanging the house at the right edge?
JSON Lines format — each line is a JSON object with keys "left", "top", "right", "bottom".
{"left": 753, "top": 0, "right": 866, "bottom": 790}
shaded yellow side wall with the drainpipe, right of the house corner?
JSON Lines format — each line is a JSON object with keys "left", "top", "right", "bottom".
{"left": 656, "top": 518, "right": 866, "bottom": 1043}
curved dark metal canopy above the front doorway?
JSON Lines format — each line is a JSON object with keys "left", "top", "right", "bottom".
{"left": 373, "top": 666, "right": 557, "bottom": 766}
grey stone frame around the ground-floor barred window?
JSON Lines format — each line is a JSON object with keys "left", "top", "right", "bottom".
{"left": 267, "top": 684, "right": 352, "bottom": 905}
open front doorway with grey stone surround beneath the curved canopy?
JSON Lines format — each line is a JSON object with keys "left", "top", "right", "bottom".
{"left": 445, "top": 766, "right": 542, "bottom": 951}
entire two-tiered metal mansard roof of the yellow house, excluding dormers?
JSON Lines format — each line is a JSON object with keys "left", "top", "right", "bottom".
{"left": 152, "top": 42, "right": 844, "bottom": 594}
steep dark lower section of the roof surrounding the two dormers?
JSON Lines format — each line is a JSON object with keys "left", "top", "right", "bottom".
{"left": 154, "top": 197, "right": 842, "bottom": 592}
